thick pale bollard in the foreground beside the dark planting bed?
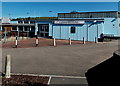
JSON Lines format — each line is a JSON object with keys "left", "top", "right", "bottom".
{"left": 5, "top": 55, "right": 11, "bottom": 78}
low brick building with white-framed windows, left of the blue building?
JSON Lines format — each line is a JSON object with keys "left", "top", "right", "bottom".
{"left": 0, "top": 17, "right": 35, "bottom": 36}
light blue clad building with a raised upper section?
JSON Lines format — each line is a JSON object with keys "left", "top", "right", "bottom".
{"left": 35, "top": 11, "right": 120, "bottom": 41}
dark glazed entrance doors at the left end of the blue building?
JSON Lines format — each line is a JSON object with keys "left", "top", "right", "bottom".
{"left": 38, "top": 24, "right": 49, "bottom": 38}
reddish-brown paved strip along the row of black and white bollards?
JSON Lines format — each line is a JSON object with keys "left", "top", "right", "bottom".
{"left": 2, "top": 38, "right": 95, "bottom": 48}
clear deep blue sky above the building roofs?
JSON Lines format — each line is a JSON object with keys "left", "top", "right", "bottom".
{"left": 2, "top": 2, "right": 118, "bottom": 18}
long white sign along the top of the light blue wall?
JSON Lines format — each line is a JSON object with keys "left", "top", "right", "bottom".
{"left": 54, "top": 20, "right": 85, "bottom": 24}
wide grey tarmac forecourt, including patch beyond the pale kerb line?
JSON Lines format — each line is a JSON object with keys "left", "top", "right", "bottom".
{"left": 2, "top": 41, "right": 118, "bottom": 86}
